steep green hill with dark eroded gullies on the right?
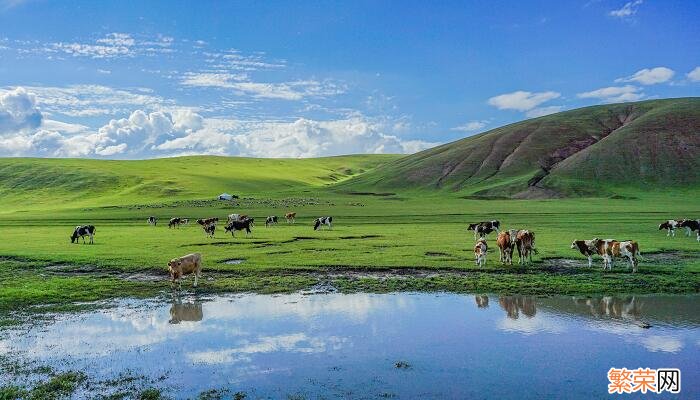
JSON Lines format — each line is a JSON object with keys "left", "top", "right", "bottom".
{"left": 339, "top": 98, "right": 700, "bottom": 198}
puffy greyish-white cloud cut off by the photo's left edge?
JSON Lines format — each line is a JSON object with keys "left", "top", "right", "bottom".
{"left": 0, "top": 88, "right": 43, "bottom": 135}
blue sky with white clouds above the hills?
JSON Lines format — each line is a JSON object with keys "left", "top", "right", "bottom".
{"left": 0, "top": 0, "right": 700, "bottom": 159}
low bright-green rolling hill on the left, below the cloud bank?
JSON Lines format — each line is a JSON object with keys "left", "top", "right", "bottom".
{"left": 0, "top": 155, "right": 399, "bottom": 211}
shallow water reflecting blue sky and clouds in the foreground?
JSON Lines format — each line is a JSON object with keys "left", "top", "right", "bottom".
{"left": 0, "top": 293, "right": 700, "bottom": 399}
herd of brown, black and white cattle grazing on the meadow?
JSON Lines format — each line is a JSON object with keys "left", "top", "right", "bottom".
{"left": 71, "top": 216, "right": 700, "bottom": 286}
